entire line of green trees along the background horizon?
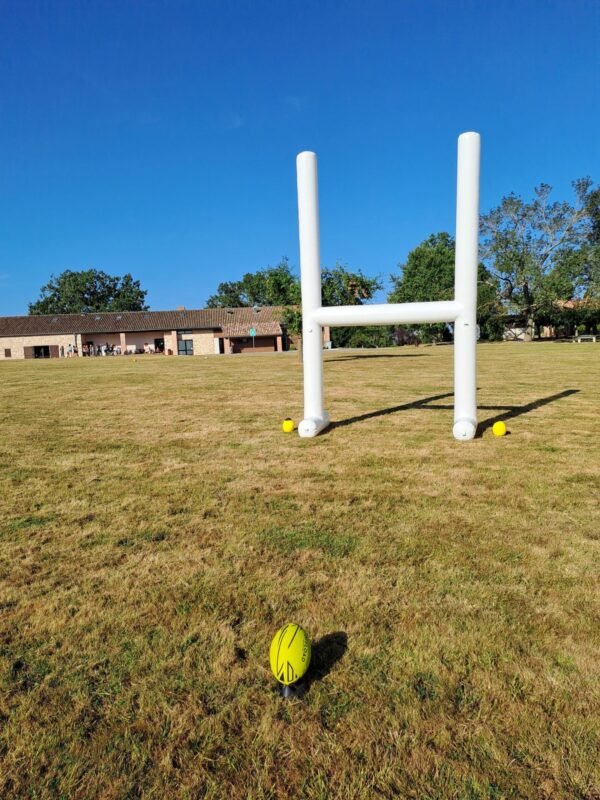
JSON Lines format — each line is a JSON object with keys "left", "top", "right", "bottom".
{"left": 29, "top": 178, "right": 600, "bottom": 347}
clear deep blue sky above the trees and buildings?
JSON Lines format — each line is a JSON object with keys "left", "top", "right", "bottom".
{"left": 0, "top": 0, "right": 600, "bottom": 314}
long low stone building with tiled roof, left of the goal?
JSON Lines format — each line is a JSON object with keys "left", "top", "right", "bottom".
{"left": 0, "top": 307, "right": 289, "bottom": 361}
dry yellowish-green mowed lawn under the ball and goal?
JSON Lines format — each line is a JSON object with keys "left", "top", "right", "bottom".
{"left": 0, "top": 343, "right": 600, "bottom": 800}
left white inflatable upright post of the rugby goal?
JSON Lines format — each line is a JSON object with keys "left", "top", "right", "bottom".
{"left": 296, "top": 151, "right": 329, "bottom": 437}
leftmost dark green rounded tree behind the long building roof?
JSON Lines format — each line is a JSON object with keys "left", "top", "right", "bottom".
{"left": 29, "top": 269, "right": 148, "bottom": 315}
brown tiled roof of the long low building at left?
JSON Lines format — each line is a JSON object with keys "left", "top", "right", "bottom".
{"left": 0, "top": 306, "right": 284, "bottom": 337}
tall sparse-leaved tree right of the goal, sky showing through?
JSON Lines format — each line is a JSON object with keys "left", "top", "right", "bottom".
{"left": 481, "top": 178, "right": 593, "bottom": 339}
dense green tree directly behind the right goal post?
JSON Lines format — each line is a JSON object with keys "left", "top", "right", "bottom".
{"left": 388, "top": 232, "right": 503, "bottom": 340}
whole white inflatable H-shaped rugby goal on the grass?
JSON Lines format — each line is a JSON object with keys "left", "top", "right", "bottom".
{"left": 296, "top": 133, "right": 480, "bottom": 441}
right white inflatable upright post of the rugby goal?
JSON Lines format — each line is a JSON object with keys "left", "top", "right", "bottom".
{"left": 452, "top": 133, "right": 480, "bottom": 440}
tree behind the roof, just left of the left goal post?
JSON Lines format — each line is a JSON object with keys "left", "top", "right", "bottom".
{"left": 206, "top": 258, "right": 300, "bottom": 308}
